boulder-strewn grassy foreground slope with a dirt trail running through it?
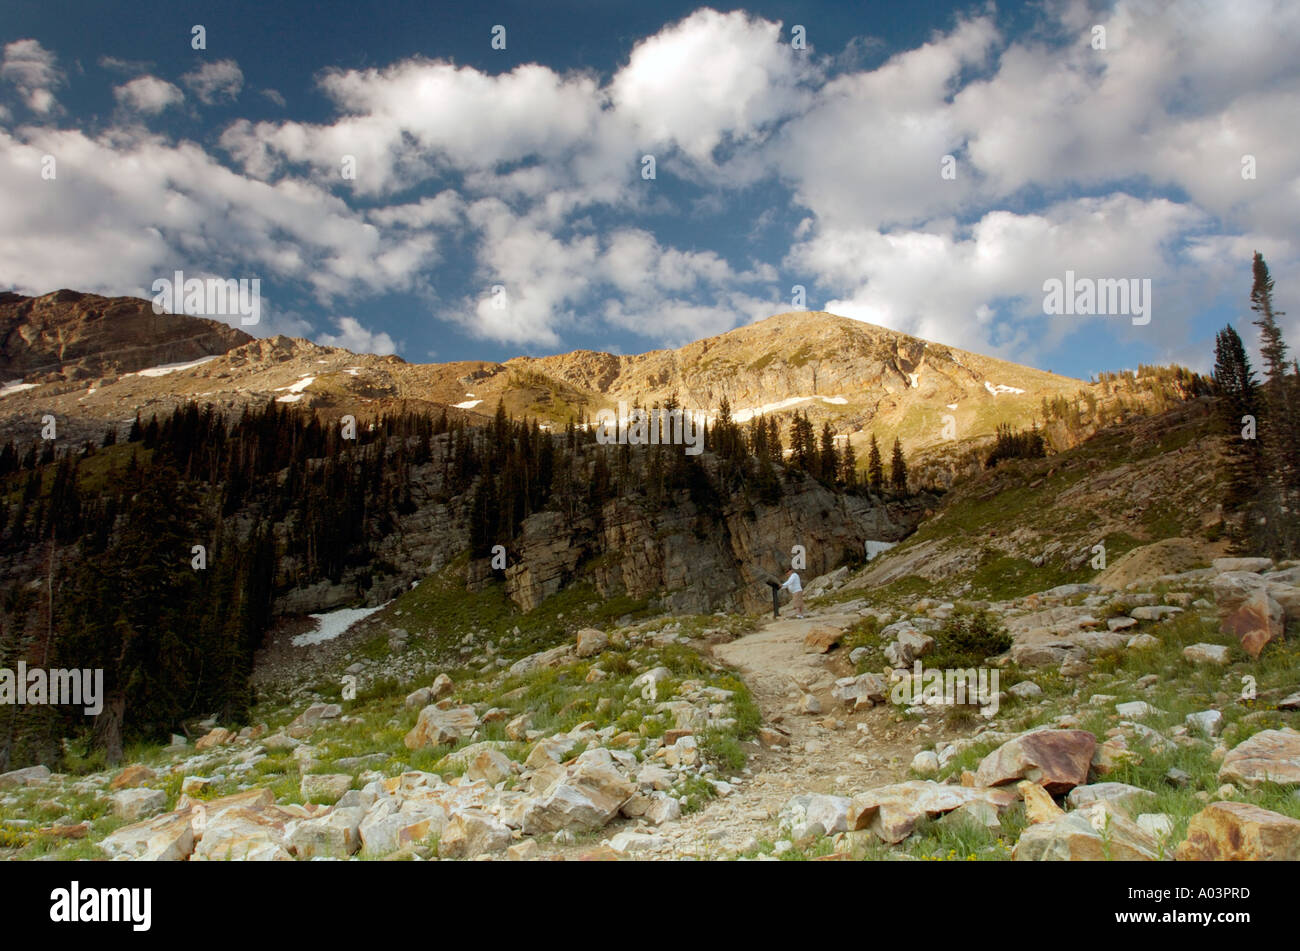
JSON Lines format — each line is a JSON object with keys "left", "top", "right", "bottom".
{"left": 0, "top": 543, "right": 1300, "bottom": 861}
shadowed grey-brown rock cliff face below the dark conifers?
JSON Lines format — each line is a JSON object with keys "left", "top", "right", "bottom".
{"left": 269, "top": 444, "right": 937, "bottom": 613}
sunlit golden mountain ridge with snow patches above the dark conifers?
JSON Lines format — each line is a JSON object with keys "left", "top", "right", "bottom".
{"left": 0, "top": 291, "right": 1190, "bottom": 465}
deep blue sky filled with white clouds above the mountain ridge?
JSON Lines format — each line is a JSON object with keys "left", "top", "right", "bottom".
{"left": 0, "top": 0, "right": 1300, "bottom": 377}
